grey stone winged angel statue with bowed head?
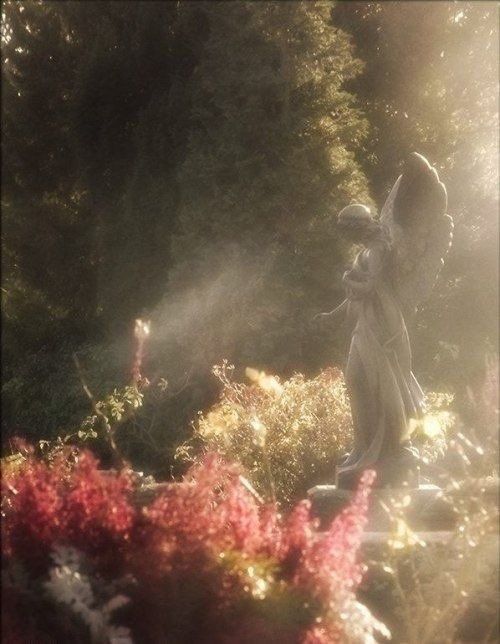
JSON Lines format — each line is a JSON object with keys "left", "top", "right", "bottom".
{"left": 319, "top": 152, "right": 453, "bottom": 489}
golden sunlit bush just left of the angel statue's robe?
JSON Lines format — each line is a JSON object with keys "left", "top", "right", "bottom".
{"left": 178, "top": 362, "right": 352, "bottom": 505}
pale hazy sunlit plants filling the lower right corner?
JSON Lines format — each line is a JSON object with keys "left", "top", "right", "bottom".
{"left": 361, "top": 363, "right": 499, "bottom": 644}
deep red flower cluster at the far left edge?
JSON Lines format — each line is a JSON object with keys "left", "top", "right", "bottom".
{"left": 2, "top": 451, "right": 134, "bottom": 568}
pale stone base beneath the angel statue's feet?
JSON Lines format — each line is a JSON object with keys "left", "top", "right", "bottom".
{"left": 307, "top": 484, "right": 455, "bottom": 532}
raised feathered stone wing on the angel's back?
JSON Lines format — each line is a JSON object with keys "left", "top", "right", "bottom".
{"left": 380, "top": 152, "right": 453, "bottom": 314}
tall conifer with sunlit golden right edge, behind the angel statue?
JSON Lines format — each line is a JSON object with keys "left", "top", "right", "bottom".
{"left": 166, "top": 2, "right": 369, "bottom": 380}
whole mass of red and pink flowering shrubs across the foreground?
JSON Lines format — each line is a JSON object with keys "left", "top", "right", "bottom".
{"left": 2, "top": 452, "right": 382, "bottom": 644}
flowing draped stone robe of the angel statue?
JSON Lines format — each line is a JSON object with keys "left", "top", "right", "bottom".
{"left": 337, "top": 235, "right": 424, "bottom": 487}
